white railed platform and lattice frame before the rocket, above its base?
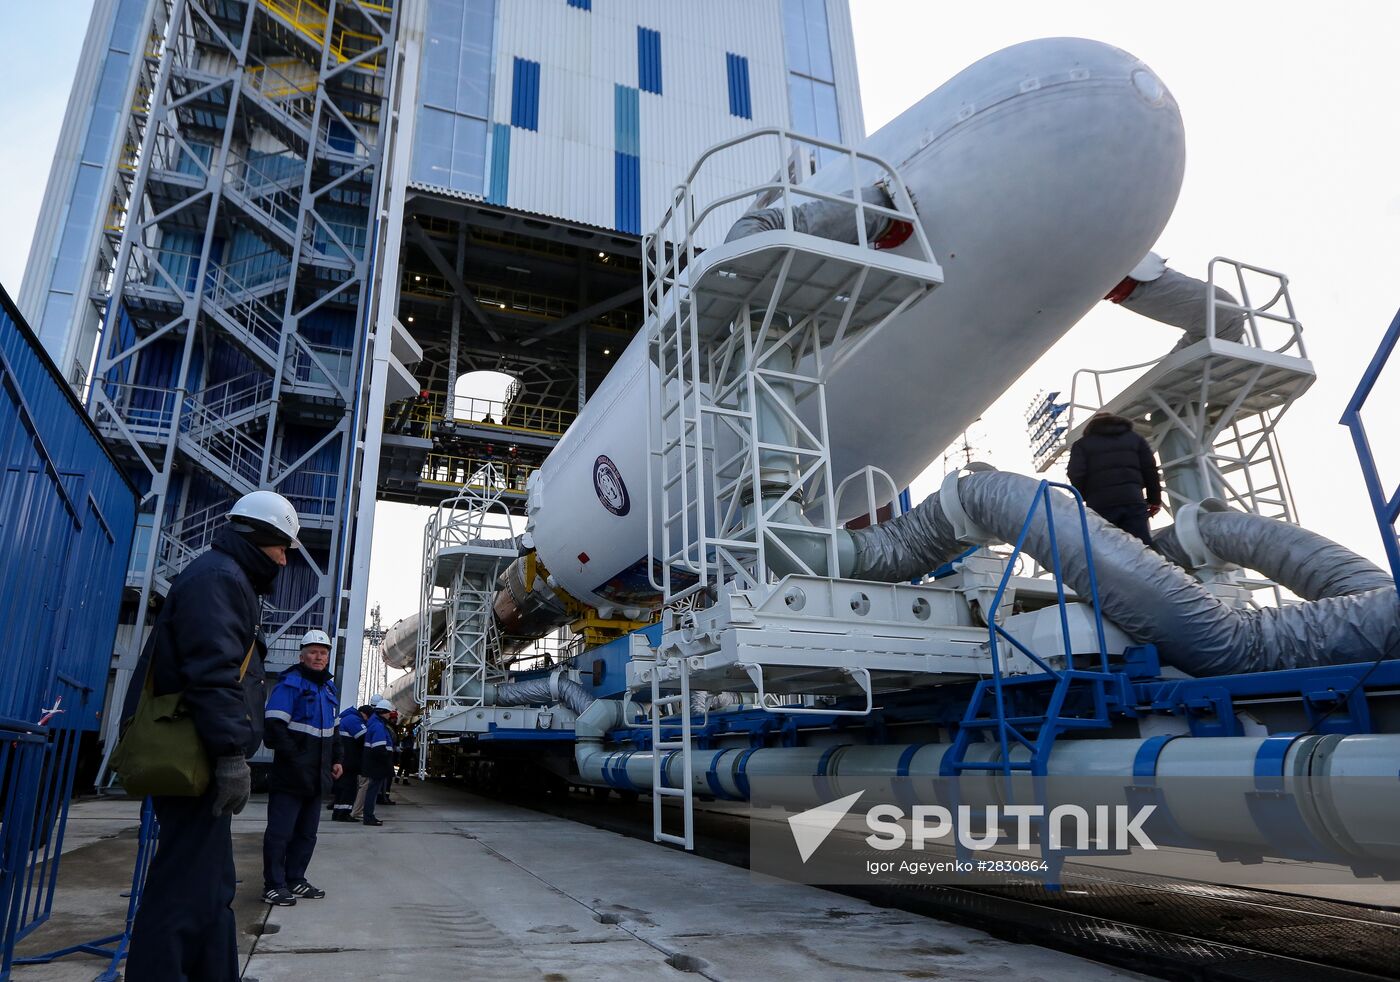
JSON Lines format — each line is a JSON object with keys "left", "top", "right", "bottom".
{"left": 643, "top": 129, "right": 942, "bottom": 604}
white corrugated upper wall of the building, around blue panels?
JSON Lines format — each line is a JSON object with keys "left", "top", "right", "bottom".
{"left": 487, "top": 0, "right": 864, "bottom": 241}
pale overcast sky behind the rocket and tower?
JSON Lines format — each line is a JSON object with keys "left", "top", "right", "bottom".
{"left": 0, "top": 0, "right": 1400, "bottom": 622}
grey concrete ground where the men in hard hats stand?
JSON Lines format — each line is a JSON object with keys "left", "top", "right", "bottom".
{"left": 14, "top": 784, "right": 1140, "bottom": 982}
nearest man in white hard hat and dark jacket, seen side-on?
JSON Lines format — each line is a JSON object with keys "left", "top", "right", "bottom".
{"left": 123, "top": 492, "right": 300, "bottom": 982}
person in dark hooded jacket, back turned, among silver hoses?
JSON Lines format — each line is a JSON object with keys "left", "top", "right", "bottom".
{"left": 1070, "top": 412, "right": 1162, "bottom": 549}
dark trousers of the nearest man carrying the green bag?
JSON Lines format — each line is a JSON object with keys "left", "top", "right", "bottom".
{"left": 126, "top": 784, "right": 238, "bottom": 982}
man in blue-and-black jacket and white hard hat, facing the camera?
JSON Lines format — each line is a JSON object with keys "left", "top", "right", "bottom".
{"left": 263, "top": 630, "right": 343, "bottom": 906}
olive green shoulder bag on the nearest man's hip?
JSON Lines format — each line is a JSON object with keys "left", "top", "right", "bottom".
{"left": 111, "top": 640, "right": 258, "bottom": 798}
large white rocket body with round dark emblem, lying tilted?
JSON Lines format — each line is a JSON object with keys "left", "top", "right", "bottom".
{"left": 496, "top": 38, "right": 1186, "bottom": 636}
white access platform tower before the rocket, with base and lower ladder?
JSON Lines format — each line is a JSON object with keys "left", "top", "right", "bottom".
{"left": 629, "top": 129, "right": 942, "bottom": 849}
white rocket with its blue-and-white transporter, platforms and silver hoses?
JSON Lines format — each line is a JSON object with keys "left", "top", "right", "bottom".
{"left": 384, "top": 38, "right": 1400, "bottom": 873}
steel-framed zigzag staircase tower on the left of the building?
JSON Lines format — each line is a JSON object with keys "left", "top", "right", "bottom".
{"left": 90, "top": 0, "right": 398, "bottom": 747}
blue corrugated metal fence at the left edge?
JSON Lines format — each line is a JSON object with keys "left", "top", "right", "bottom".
{"left": 0, "top": 290, "right": 137, "bottom": 979}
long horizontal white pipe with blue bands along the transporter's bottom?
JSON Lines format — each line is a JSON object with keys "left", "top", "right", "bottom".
{"left": 575, "top": 711, "right": 1400, "bottom": 864}
